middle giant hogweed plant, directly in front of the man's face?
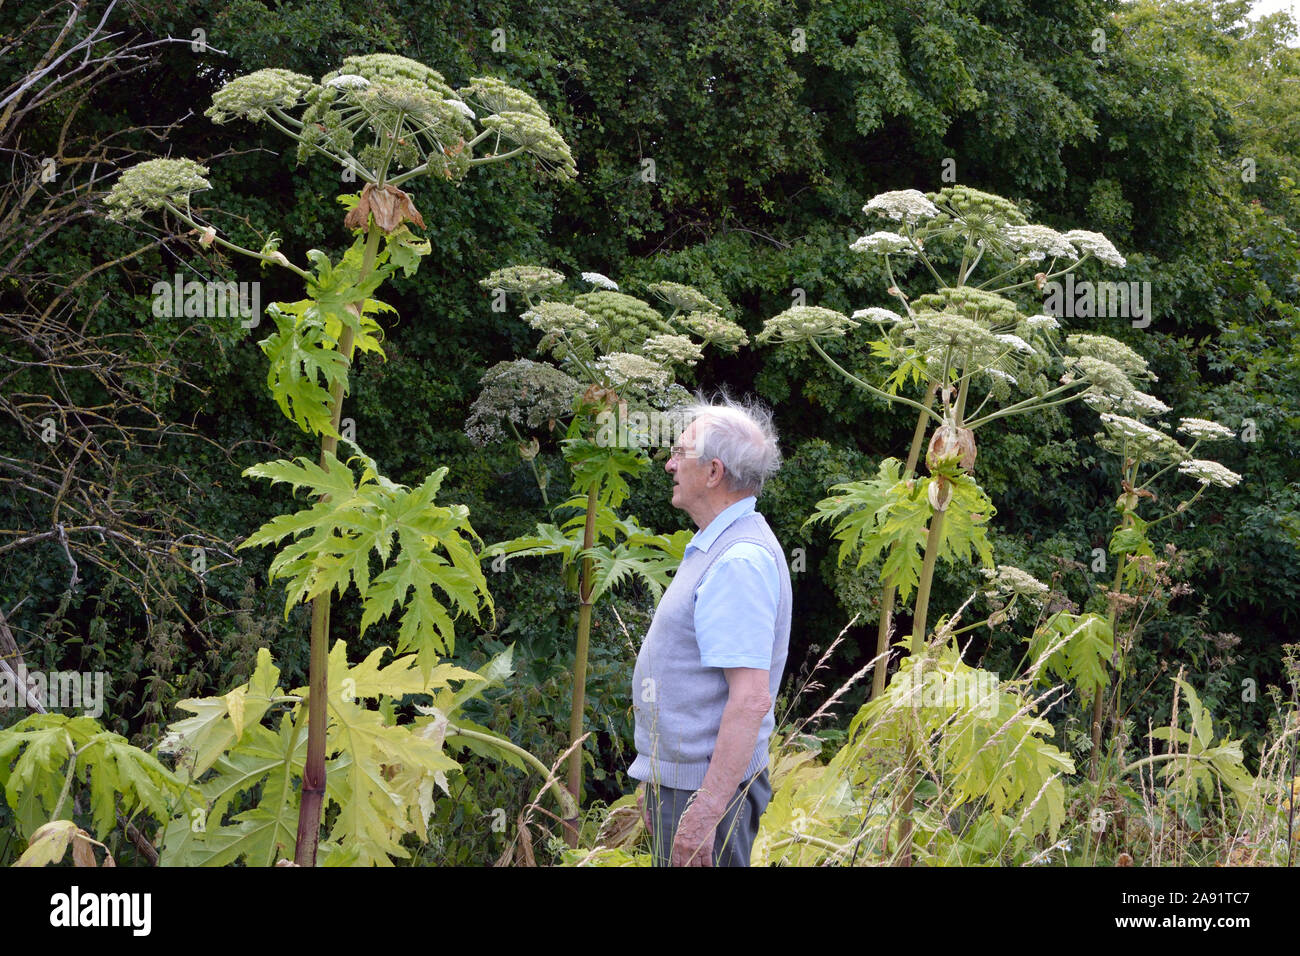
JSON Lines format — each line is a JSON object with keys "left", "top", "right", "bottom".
{"left": 465, "top": 265, "right": 748, "bottom": 847}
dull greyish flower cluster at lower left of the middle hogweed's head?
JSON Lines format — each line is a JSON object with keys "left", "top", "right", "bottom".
{"left": 465, "top": 359, "right": 581, "bottom": 446}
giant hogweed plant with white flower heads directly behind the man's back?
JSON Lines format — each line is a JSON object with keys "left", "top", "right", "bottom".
{"left": 758, "top": 186, "right": 1145, "bottom": 862}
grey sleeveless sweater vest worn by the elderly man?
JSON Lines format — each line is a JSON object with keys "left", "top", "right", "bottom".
{"left": 628, "top": 511, "right": 790, "bottom": 790}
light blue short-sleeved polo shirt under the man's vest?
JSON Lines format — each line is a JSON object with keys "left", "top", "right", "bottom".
{"left": 685, "top": 496, "right": 781, "bottom": 671}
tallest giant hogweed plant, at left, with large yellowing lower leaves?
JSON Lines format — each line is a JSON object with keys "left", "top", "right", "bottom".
{"left": 92, "top": 55, "right": 576, "bottom": 865}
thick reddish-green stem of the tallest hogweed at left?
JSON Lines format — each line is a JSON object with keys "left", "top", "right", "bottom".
{"left": 294, "top": 217, "right": 382, "bottom": 866}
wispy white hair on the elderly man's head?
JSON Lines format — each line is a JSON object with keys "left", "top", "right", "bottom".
{"left": 681, "top": 392, "right": 781, "bottom": 497}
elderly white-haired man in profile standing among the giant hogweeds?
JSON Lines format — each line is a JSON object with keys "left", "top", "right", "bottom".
{"left": 628, "top": 398, "right": 790, "bottom": 866}
